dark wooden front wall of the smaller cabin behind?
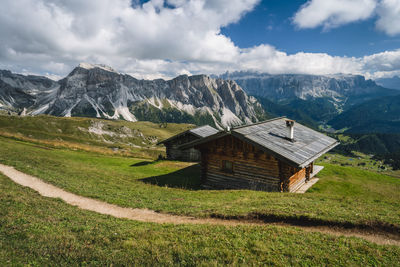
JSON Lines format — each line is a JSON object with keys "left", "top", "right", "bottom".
{"left": 165, "top": 133, "right": 201, "bottom": 161}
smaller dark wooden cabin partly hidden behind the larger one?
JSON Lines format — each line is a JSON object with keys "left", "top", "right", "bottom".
{"left": 159, "top": 125, "right": 219, "bottom": 161}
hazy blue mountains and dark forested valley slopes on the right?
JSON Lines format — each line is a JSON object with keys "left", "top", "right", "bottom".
{"left": 217, "top": 72, "right": 400, "bottom": 165}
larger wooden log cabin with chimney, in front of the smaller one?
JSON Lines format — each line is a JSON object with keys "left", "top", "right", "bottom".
{"left": 183, "top": 118, "right": 338, "bottom": 192}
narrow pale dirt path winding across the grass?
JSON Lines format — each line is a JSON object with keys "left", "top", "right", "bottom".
{"left": 0, "top": 164, "right": 400, "bottom": 246}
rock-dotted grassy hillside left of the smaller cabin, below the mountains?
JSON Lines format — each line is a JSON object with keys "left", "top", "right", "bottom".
{"left": 0, "top": 114, "right": 194, "bottom": 158}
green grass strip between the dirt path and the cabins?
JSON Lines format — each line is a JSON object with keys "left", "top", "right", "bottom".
{"left": 0, "top": 138, "right": 400, "bottom": 227}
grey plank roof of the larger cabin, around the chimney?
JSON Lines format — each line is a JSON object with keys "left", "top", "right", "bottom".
{"left": 185, "top": 117, "right": 339, "bottom": 168}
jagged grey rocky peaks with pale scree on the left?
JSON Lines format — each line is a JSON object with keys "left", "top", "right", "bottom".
{"left": 0, "top": 64, "right": 263, "bottom": 127}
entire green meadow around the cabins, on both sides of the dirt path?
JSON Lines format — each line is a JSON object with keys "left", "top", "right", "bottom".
{"left": 0, "top": 116, "right": 400, "bottom": 266}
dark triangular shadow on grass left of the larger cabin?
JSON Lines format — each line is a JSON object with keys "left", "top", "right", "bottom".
{"left": 140, "top": 164, "right": 202, "bottom": 190}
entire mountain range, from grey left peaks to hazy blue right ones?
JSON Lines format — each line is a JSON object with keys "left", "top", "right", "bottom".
{"left": 0, "top": 66, "right": 400, "bottom": 133}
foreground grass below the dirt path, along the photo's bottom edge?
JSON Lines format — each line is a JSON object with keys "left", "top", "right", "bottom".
{"left": 0, "top": 175, "right": 400, "bottom": 266}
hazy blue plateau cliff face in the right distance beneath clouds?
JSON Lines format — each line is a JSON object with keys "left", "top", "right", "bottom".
{"left": 219, "top": 72, "right": 393, "bottom": 108}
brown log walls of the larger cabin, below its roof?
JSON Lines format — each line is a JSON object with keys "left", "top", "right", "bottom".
{"left": 197, "top": 136, "right": 306, "bottom": 191}
